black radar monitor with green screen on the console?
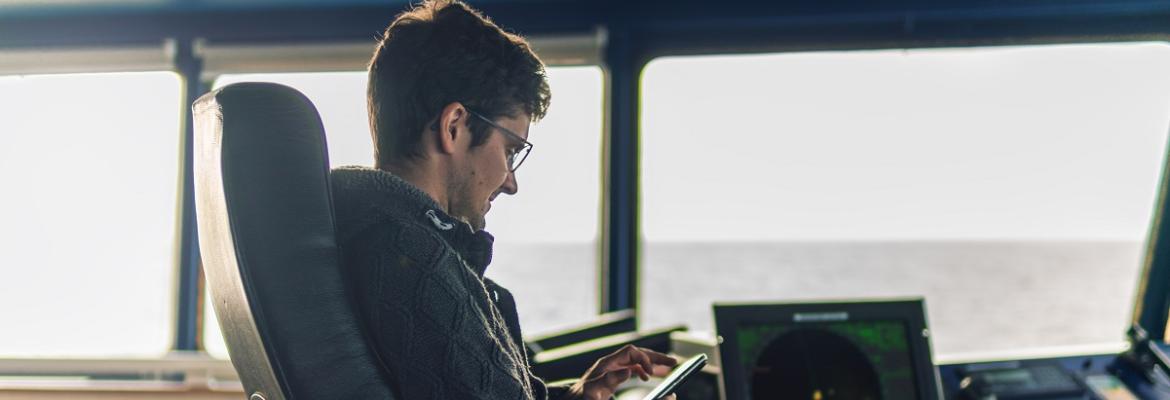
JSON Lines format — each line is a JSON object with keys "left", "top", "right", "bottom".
{"left": 715, "top": 298, "right": 941, "bottom": 400}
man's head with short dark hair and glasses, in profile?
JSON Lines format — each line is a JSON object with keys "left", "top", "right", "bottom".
{"left": 367, "top": 0, "right": 550, "bottom": 229}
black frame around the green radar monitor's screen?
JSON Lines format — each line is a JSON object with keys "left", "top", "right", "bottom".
{"left": 714, "top": 297, "right": 942, "bottom": 400}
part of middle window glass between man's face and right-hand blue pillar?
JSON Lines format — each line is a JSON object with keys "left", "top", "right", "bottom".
{"left": 487, "top": 67, "right": 604, "bottom": 336}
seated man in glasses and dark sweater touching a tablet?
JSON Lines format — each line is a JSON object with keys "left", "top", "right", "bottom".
{"left": 332, "top": 1, "right": 675, "bottom": 400}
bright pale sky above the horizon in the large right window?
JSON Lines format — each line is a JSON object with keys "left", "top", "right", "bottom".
{"left": 641, "top": 44, "right": 1170, "bottom": 241}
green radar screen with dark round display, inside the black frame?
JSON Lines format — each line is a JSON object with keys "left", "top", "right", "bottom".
{"left": 737, "top": 322, "right": 917, "bottom": 400}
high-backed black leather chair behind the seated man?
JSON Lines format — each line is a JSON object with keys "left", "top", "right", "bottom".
{"left": 194, "top": 83, "right": 394, "bottom": 400}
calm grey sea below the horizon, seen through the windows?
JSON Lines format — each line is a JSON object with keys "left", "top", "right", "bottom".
{"left": 488, "top": 240, "right": 1144, "bottom": 361}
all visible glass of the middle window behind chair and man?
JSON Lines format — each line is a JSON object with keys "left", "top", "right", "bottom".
{"left": 205, "top": 67, "right": 603, "bottom": 357}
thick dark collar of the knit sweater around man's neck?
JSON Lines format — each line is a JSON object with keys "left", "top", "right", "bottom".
{"left": 330, "top": 166, "right": 495, "bottom": 277}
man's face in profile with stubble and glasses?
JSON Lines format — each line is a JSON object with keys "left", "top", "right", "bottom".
{"left": 450, "top": 115, "right": 531, "bottom": 230}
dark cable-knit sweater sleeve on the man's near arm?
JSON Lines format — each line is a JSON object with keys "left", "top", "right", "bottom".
{"left": 343, "top": 225, "right": 543, "bottom": 400}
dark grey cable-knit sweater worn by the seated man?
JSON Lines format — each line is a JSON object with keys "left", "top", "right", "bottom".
{"left": 330, "top": 167, "right": 564, "bottom": 400}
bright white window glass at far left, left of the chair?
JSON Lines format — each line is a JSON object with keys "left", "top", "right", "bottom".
{"left": 0, "top": 73, "right": 181, "bottom": 357}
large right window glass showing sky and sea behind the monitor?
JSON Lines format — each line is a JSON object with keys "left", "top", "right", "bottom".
{"left": 640, "top": 43, "right": 1170, "bottom": 359}
